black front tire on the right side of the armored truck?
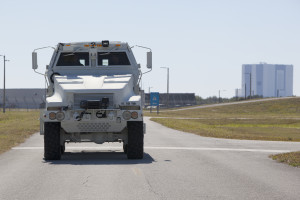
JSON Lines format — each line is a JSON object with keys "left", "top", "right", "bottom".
{"left": 127, "top": 121, "right": 144, "bottom": 159}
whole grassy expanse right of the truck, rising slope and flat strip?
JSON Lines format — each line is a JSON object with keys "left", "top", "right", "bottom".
{"left": 145, "top": 98, "right": 300, "bottom": 141}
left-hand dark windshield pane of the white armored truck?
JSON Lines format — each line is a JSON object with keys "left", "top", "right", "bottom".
{"left": 57, "top": 52, "right": 90, "bottom": 66}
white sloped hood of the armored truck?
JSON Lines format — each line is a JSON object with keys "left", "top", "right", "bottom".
{"left": 46, "top": 74, "right": 134, "bottom": 106}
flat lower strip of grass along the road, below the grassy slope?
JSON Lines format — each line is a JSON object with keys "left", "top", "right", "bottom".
{"left": 151, "top": 118, "right": 300, "bottom": 142}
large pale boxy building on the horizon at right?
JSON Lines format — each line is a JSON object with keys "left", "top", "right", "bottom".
{"left": 238, "top": 63, "right": 293, "bottom": 97}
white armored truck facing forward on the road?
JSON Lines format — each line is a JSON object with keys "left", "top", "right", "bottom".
{"left": 32, "top": 40, "right": 152, "bottom": 160}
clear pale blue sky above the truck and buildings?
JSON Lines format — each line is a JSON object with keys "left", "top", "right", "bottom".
{"left": 0, "top": 0, "right": 300, "bottom": 97}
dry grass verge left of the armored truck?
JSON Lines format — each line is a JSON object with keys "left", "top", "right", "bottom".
{"left": 0, "top": 110, "right": 39, "bottom": 153}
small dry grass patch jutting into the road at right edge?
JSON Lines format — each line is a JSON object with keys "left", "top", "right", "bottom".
{"left": 270, "top": 151, "right": 300, "bottom": 167}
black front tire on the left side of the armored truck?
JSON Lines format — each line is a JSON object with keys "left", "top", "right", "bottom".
{"left": 44, "top": 122, "right": 61, "bottom": 160}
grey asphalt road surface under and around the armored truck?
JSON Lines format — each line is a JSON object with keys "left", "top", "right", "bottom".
{"left": 0, "top": 119, "right": 300, "bottom": 200}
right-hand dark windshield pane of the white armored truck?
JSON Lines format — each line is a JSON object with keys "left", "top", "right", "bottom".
{"left": 98, "top": 52, "right": 130, "bottom": 66}
